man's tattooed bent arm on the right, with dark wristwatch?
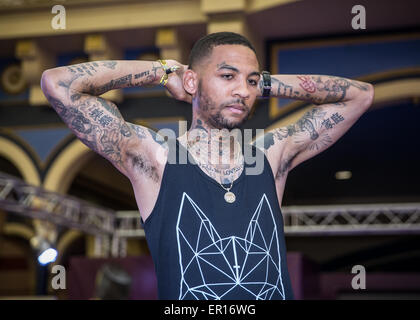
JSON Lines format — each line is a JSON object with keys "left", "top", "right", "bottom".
{"left": 260, "top": 75, "right": 374, "bottom": 177}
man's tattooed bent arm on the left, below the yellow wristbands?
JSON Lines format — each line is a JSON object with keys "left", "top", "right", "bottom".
{"left": 41, "top": 61, "right": 176, "bottom": 181}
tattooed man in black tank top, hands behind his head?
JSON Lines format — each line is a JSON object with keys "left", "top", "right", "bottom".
{"left": 41, "top": 32, "right": 373, "bottom": 299}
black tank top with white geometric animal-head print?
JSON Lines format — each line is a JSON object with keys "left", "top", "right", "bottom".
{"left": 144, "top": 140, "right": 293, "bottom": 300}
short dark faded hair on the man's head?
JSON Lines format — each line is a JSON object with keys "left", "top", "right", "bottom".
{"left": 188, "top": 32, "right": 257, "bottom": 69}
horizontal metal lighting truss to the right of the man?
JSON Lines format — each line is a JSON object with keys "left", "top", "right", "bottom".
{"left": 282, "top": 203, "right": 420, "bottom": 236}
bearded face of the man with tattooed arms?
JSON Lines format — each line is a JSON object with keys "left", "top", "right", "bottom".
{"left": 197, "top": 45, "right": 260, "bottom": 130}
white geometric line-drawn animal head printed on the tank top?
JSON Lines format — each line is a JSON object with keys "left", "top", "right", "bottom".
{"left": 176, "top": 192, "right": 285, "bottom": 300}
